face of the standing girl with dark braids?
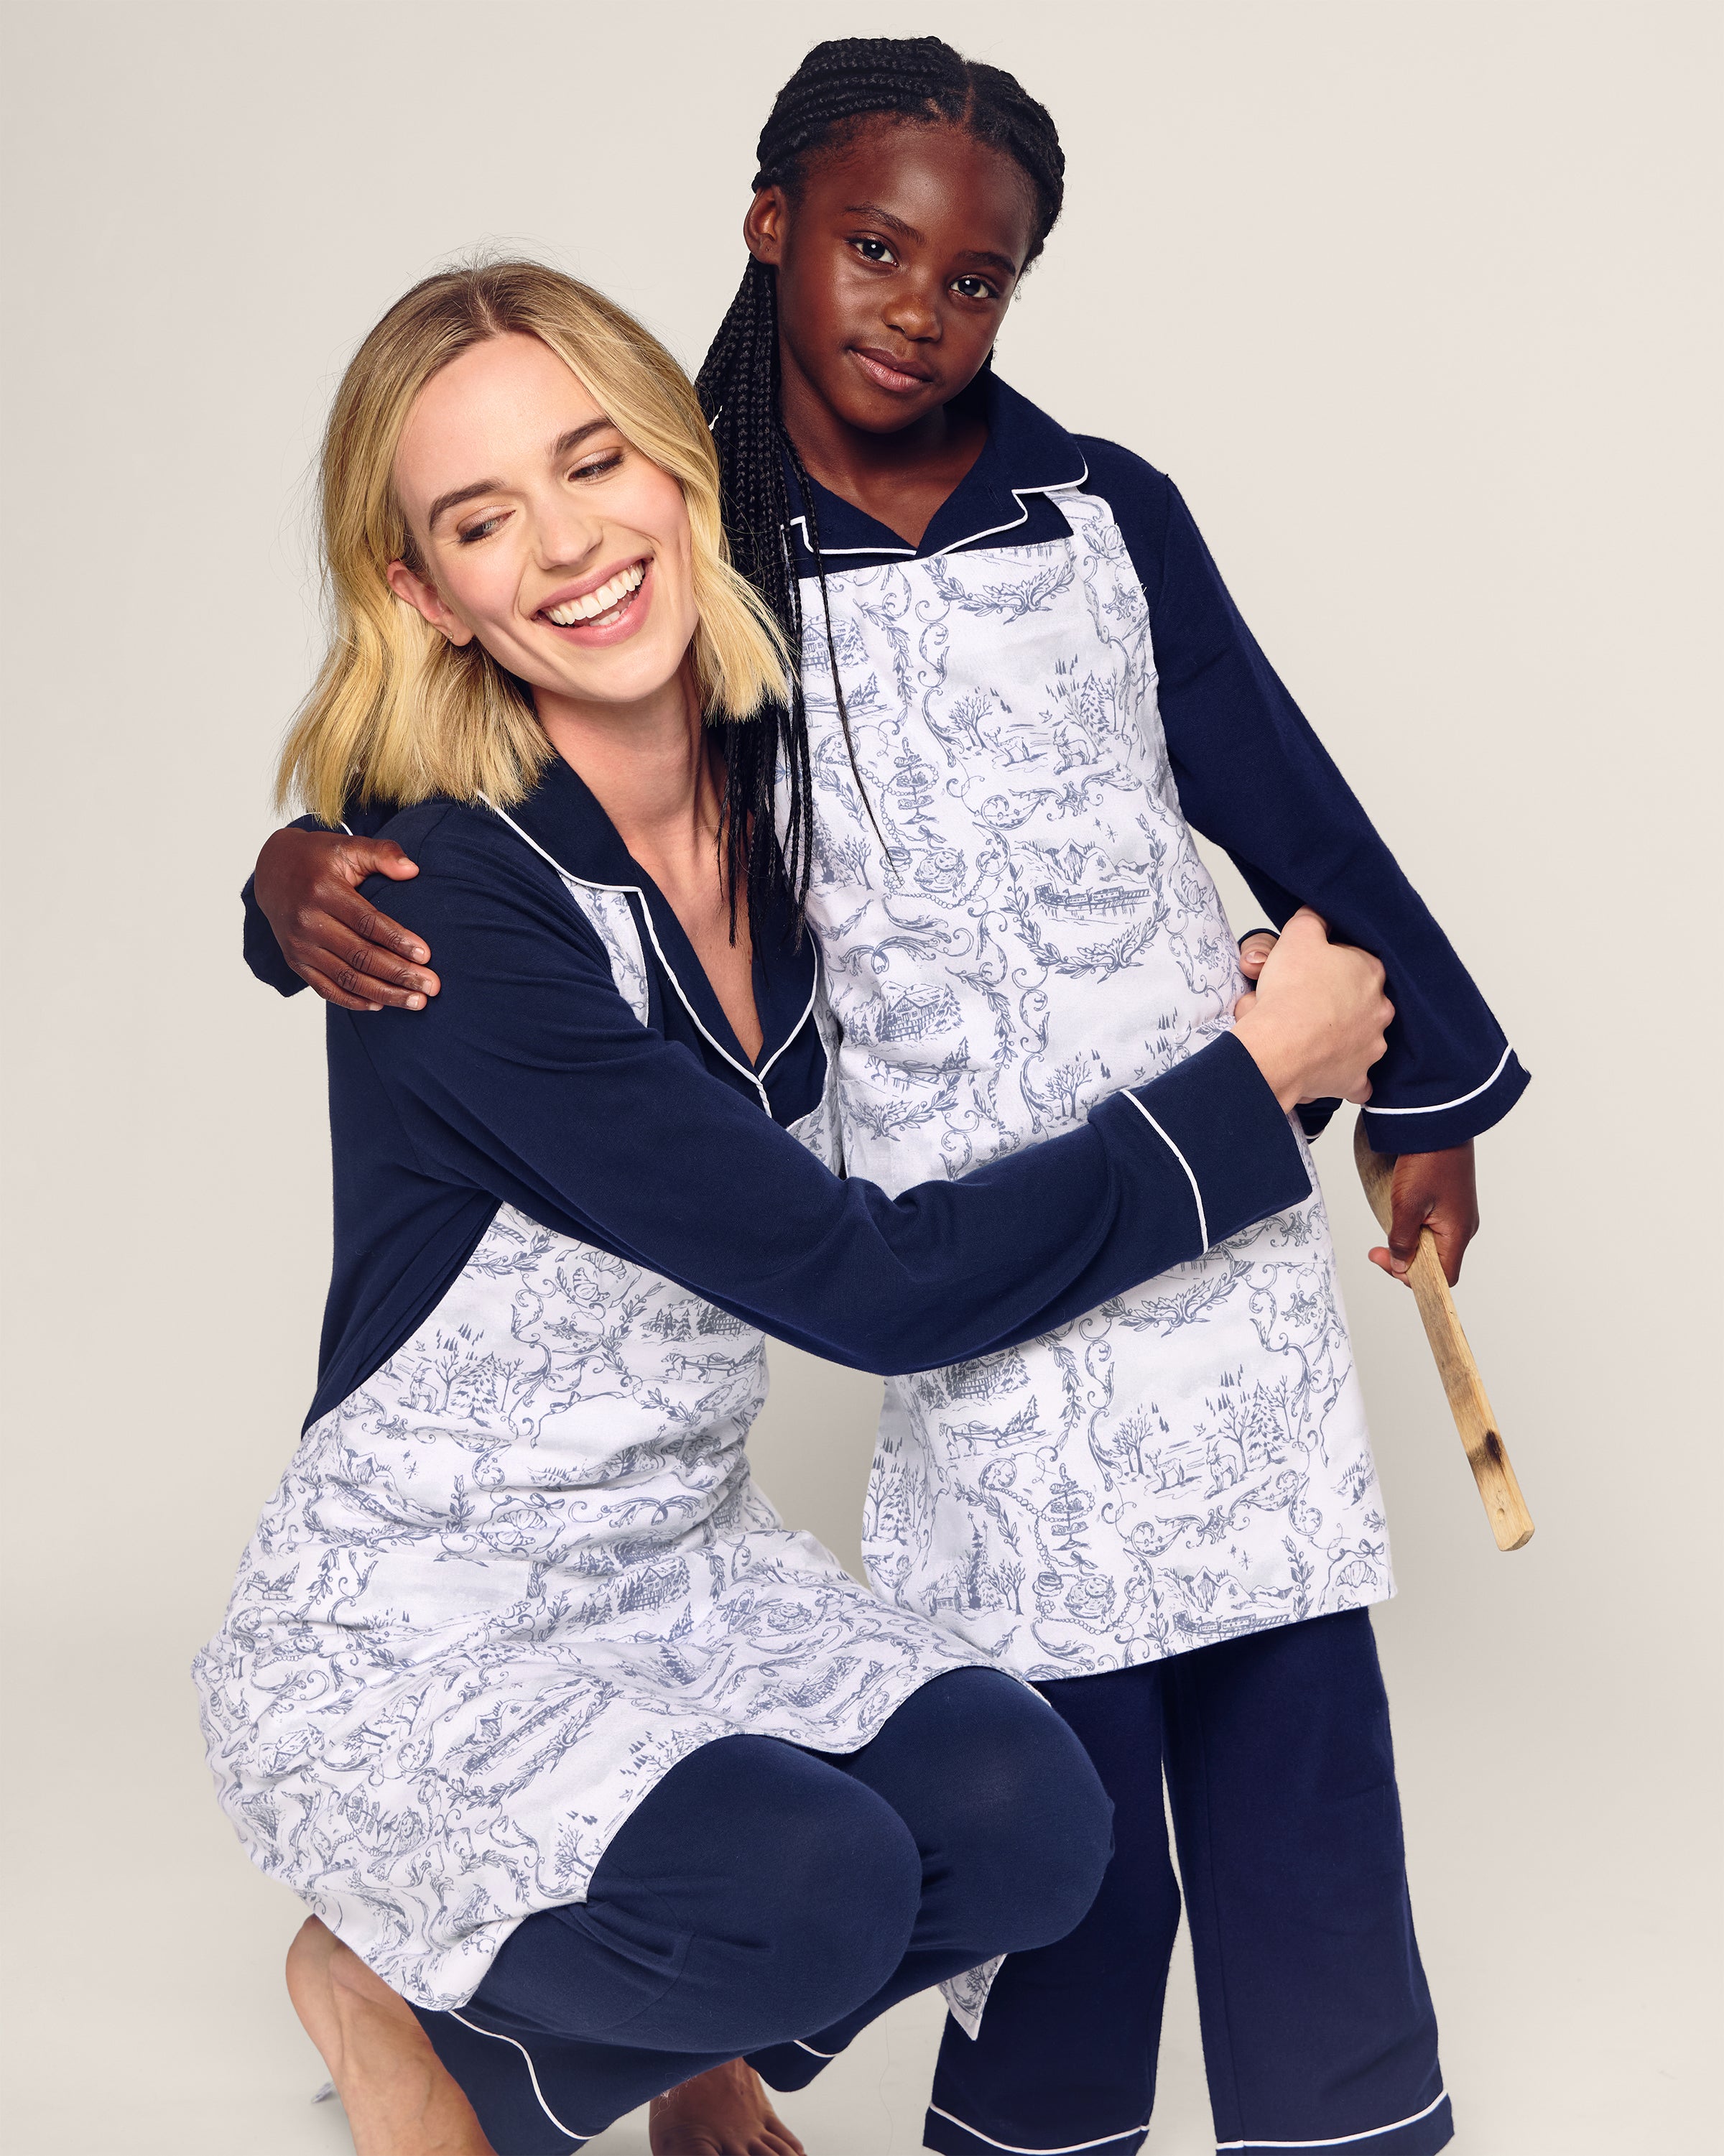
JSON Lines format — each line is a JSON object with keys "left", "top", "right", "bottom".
{"left": 743, "top": 121, "right": 1034, "bottom": 433}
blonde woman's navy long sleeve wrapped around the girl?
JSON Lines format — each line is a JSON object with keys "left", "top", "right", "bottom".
{"left": 330, "top": 810, "right": 1310, "bottom": 1374}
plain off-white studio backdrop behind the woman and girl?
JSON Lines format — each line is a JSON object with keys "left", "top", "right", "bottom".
{"left": 0, "top": 0, "right": 1722, "bottom": 2156}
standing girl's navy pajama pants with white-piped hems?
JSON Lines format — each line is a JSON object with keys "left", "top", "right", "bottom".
{"left": 797, "top": 1611, "right": 1452, "bottom": 2156}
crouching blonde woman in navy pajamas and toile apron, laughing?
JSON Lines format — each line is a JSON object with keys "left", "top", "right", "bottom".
{"left": 198, "top": 263, "right": 1388, "bottom": 2156}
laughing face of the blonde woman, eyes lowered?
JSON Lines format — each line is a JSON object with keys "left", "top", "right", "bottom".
{"left": 388, "top": 332, "right": 696, "bottom": 703}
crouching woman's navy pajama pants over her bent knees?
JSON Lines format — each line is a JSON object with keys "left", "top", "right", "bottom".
{"left": 414, "top": 1669, "right": 1110, "bottom": 2156}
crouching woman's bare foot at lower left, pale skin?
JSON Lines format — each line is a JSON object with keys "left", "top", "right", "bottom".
{"left": 287, "top": 1917, "right": 496, "bottom": 2156}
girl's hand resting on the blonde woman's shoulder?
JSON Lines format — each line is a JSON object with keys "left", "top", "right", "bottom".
{"left": 254, "top": 830, "right": 442, "bottom": 1011}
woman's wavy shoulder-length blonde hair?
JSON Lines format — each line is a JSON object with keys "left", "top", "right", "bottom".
{"left": 276, "top": 261, "right": 787, "bottom": 823}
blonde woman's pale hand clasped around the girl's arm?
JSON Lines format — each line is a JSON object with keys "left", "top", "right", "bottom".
{"left": 1233, "top": 905, "right": 1394, "bottom": 1111}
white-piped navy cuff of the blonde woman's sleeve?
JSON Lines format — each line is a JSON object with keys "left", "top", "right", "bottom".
{"left": 1103, "top": 1032, "right": 1310, "bottom": 1253}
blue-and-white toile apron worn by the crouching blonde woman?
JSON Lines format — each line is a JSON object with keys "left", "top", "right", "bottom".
{"left": 196, "top": 879, "right": 978, "bottom": 2007}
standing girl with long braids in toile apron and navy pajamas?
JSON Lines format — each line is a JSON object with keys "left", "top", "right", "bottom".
{"left": 250, "top": 39, "right": 1526, "bottom": 2156}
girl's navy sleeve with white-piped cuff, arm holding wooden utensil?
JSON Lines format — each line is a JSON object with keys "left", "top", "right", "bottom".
{"left": 1086, "top": 442, "right": 1528, "bottom": 1154}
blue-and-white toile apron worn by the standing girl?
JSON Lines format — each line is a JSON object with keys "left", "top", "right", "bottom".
{"left": 804, "top": 489, "right": 1392, "bottom": 1678}
